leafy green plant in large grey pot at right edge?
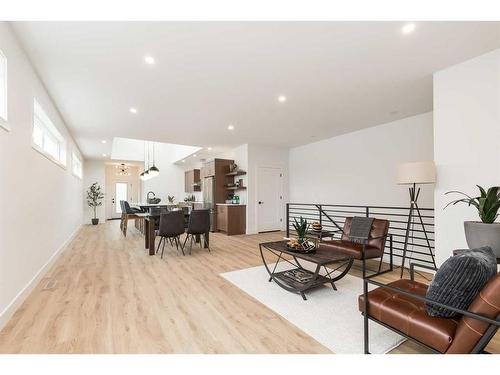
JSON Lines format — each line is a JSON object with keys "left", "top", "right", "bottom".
{"left": 445, "top": 185, "right": 500, "bottom": 258}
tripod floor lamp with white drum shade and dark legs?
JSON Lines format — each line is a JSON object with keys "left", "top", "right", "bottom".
{"left": 398, "top": 161, "right": 437, "bottom": 277}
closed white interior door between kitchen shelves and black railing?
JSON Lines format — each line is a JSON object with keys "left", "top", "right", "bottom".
{"left": 257, "top": 167, "right": 283, "bottom": 232}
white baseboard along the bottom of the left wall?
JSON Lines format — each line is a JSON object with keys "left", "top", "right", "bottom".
{"left": 0, "top": 225, "right": 82, "bottom": 330}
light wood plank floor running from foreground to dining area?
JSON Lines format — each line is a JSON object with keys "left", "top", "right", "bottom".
{"left": 0, "top": 221, "right": 500, "bottom": 353}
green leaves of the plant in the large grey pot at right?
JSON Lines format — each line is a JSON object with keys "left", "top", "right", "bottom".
{"left": 445, "top": 185, "right": 500, "bottom": 224}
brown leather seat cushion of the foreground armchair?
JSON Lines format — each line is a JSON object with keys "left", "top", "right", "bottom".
{"left": 358, "top": 279, "right": 458, "bottom": 353}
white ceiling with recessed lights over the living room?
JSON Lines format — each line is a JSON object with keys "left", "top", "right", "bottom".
{"left": 9, "top": 22, "right": 500, "bottom": 157}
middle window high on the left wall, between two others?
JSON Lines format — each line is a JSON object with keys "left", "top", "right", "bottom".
{"left": 33, "top": 100, "right": 66, "bottom": 166}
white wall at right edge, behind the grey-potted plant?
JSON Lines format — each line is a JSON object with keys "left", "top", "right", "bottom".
{"left": 434, "top": 50, "right": 500, "bottom": 264}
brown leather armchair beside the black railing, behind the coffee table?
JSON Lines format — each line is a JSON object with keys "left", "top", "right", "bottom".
{"left": 322, "top": 217, "right": 393, "bottom": 278}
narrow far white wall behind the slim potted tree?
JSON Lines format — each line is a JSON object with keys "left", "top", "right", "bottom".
{"left": 83, "top": 160, "right": 106, "bottom": 224}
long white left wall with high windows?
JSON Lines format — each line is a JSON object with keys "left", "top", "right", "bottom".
{"left": 0, "top": 22, "right": 83, "bottom": 327}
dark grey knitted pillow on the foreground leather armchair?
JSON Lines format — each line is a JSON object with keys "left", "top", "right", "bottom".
{"left": 426, "top": 250, "right": 493, "bottom": 318}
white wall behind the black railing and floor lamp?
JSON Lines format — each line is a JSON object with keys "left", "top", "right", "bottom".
{"left": 290, "top": 113, "right": 434, "bottom": 207}
